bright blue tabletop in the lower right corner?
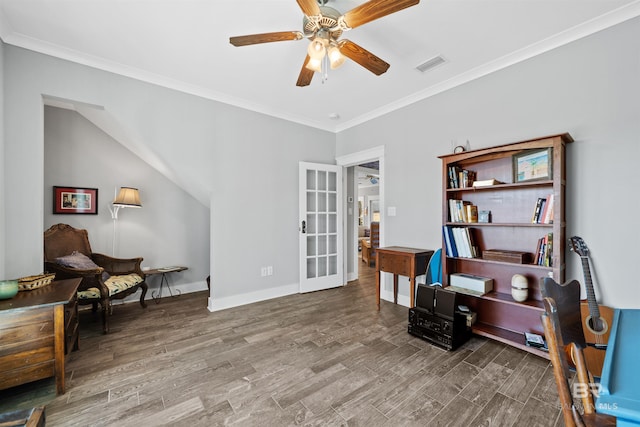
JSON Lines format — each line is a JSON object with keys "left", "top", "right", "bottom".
{"left": 596, "top": 309, "right": 640, "bottom": 427}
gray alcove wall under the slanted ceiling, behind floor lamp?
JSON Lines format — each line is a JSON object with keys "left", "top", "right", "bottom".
{"left": 44, "top": 106, "right": 209, "bottom": 299}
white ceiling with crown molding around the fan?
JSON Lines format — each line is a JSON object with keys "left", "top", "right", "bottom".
{"left": 0, "top": 0, "right": 640, "bottom": 132}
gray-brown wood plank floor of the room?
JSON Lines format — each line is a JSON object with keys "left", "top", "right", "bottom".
{"left": 0, "top": 264, "right": 563, "bottom": 427}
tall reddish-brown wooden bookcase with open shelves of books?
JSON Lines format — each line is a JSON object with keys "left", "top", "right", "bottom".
{"left": 440, "top": 134, "right": 573, "bottom": 358}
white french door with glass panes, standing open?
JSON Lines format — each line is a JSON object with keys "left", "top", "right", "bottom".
{"left": 298, "top": 162, "right": 344, "bottom": 293}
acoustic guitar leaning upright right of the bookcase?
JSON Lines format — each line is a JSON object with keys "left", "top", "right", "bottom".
{"left": 569, "top": 236, "right": 614, "bottom": 377}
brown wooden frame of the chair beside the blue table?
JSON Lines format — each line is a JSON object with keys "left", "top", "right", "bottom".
{"left": 542, "top": 297, "right": 616, "bottom": 427}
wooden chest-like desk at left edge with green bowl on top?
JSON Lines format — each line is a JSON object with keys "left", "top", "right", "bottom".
{"left": 0, "top": 278, "right": 81, "bottom": 394}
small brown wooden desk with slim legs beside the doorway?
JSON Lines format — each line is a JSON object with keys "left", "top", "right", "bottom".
{"left": 376, "top": 246, "right": 433, "bottom": 310}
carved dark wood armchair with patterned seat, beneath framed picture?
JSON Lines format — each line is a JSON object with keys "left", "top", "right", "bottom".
{"left": 44, "top": 224, "right": 147, "bottom": 334}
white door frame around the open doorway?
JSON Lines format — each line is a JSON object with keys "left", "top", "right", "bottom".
{"left": 336, "top": 145, "right": 386, "bottom": 284}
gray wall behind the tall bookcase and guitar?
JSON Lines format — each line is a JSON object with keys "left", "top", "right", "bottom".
{"left": 336, "top": 18, "right": 640, "bottom": 307}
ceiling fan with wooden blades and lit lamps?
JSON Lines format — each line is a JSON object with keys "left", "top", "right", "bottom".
{"left": 229, "top": 0, "right": 420, "bottom": 86}
